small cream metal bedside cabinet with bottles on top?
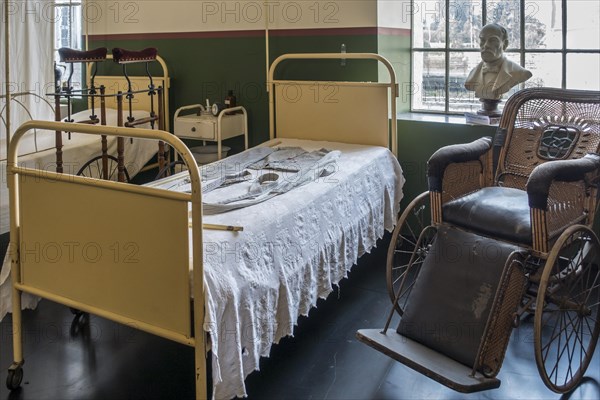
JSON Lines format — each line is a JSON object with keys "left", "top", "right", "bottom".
{"left": 173, "top": 104, "right": 248, "bottom": 159}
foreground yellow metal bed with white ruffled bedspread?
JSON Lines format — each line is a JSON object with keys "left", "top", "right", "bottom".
{"left": 7, "top": 54, "right": 404, "bottom": 398}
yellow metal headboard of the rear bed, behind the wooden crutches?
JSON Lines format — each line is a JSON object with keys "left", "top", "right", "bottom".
{"left": 86, "top": 54, "right": 171, "bottom": 131}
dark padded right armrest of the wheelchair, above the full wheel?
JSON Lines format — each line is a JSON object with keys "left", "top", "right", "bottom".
{"left": 527, "top": 153, "right": 600, "bottom": 210}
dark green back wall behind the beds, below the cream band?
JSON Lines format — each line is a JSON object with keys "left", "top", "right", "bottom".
{"left": 90, "top": 35, "right": 377, "bottom": 151}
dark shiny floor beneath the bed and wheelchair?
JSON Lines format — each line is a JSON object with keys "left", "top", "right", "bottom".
{"left": 0, "top": 234, "right": 600, "bottom": 400}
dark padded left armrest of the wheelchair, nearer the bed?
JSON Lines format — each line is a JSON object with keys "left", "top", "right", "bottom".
{"left": 427, "top": 136, "right": 492, "bottom": 192}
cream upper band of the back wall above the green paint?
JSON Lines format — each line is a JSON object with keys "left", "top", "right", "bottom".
{"left": 84, "top": 0, "right": 378, "bottom": 35}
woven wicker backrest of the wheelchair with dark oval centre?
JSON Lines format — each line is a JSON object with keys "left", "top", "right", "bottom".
{"left": 496, "top": 88, "right": 600, "bottom": 189}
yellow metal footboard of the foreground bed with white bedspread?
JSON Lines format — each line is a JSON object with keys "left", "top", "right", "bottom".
{"left": 7, "top": 121, "right": 206, "bottom": 398}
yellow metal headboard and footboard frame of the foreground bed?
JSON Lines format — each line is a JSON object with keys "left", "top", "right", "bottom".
{"left": 7, "top": 53, "right": 397, "bottom": 399}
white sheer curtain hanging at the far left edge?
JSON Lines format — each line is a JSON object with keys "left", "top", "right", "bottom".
{"left": 0, "top": 0, "right": 57, "bottom": 160}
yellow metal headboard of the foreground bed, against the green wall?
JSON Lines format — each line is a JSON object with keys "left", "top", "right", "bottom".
{"left": 269, "top": 53, "right": 398, "bottom": 154}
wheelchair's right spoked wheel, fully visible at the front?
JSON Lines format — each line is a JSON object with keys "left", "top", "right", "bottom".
{"left": 534, "top": 225, "right": 600, "bottom": 393}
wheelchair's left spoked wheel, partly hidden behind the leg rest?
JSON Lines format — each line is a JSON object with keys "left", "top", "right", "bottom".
{"left": 386, "top": 192, "right": 436, "bottom": 315}
